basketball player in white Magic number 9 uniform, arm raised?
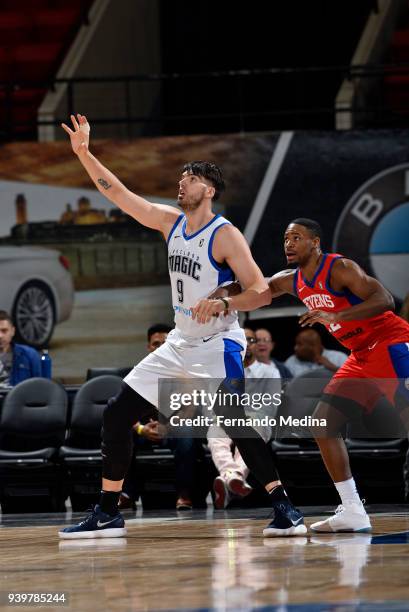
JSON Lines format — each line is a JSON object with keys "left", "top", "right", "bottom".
{"left": 60, "top": 115, "right": 306, "bottom": 538}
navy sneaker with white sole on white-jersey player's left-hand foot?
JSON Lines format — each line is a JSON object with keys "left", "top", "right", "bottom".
{"left": 58, "top": 505, "right": 126, "bottom": 540}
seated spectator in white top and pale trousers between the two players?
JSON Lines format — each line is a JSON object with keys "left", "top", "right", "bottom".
{"left": 207, "top": 327, "right": 280, "bottom": 509}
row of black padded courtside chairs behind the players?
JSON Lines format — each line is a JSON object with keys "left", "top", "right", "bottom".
{"left": 0, "top": 372, "right": 407, "bottom": 513}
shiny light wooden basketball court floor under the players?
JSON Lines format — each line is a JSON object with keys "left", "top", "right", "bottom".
{"left": 0, "top": 506, "right": 409, "bottom": 612}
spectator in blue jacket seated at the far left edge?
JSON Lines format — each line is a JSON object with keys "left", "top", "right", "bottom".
{"left": 0, "top": 310, "right": 41, "bottom": 388}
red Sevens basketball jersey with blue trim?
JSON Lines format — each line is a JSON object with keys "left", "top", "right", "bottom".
{"left": 294, "top": 253, "right": 409, "bottom": 351}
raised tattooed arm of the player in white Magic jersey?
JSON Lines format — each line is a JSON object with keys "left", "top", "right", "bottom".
{"left": 62, "top": 115, "right": 180, "bottom": 238}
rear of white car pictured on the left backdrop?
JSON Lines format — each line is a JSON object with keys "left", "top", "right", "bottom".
{"left": 0, "top": 246, "right": 74, "bottom": 348}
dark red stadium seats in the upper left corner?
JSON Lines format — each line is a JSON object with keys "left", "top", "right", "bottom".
{"left": 0, "top": 0, "right": 91, "bottom": 136}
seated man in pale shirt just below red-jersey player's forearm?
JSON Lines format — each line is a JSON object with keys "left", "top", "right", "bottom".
{"left": 285, "top": 329, "right": 348, "bottom": 376}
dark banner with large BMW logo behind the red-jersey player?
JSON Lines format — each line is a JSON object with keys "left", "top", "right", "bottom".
{"left": 236, "top": 130, "right": 409, "bottom": 306}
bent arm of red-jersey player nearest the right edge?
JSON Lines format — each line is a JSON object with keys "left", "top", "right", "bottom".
{"left": 300, "top": 259, "right": 395, "bottom": 327}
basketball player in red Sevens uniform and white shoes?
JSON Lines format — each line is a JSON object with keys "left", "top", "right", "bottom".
{"left": 269, "top": 218, "right": 409, "bottom": 533}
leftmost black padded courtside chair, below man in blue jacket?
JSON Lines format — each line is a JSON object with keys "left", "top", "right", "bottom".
{"left": 0, "top": 378, "right": 68, "bottom": 513}
